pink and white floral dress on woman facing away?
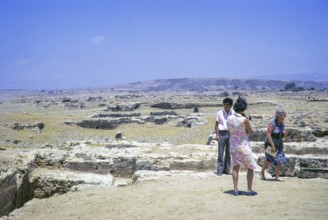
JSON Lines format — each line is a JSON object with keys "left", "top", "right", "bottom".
{"left": 227, "top": 112, "right": 257, "bottom": 169}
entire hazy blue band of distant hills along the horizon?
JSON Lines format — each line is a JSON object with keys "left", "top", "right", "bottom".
{"left": 0, "top": 72, "right": 328, "bottom": 91}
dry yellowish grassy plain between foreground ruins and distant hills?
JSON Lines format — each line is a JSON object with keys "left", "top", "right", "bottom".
{"left": 0, "top": 90, "right": 328, "bottom": 150}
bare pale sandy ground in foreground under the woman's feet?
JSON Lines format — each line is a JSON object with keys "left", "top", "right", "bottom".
{"left": 4, "top": 173, "right": 328, "bottom": 220}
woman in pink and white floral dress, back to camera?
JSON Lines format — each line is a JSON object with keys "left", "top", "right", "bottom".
{"left": 227, "top": 97, "right": 257, "bottom": 196}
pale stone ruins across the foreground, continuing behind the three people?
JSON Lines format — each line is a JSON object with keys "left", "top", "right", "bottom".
{"left": 0, "top": 141, "right": 328, "bottom": 216}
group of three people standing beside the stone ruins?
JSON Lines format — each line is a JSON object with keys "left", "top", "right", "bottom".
{"left": 215, "top": 97, "right": 287, "bottom": 196}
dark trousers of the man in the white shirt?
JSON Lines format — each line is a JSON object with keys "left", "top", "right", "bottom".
{"left": 217, "top": 131, "right": 231, "bottom": 175}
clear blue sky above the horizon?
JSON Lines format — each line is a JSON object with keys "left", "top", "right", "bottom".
{"left": 0, "top": 0, "right": 328, "bottom": 89}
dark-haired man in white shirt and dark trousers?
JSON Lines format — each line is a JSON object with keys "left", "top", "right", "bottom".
{"left": 215, "top": 98, "right": 233, "bottom": 176}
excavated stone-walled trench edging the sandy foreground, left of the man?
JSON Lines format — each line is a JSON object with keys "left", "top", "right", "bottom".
{"left": 0, "top": 146, "right": 215, "bottom": 217}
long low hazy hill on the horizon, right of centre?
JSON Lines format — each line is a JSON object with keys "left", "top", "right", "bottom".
{"left": 113, "top": 78, "right": 328, "bottom": 92}
